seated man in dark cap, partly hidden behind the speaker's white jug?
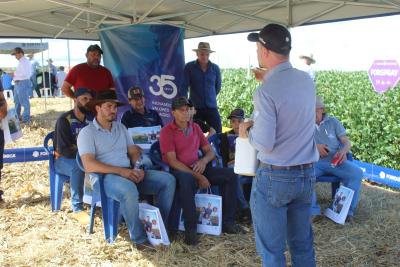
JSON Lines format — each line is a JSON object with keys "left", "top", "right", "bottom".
{"left": 219, "top": 108, "right": 253, "bottom": 223}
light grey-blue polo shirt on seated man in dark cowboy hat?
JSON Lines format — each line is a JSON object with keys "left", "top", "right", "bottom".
{"left": 77, "top": 119, "right": 133, "bottom": 168}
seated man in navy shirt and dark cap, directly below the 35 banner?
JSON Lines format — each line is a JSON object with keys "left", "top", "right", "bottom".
{"left": 121, "top": 86, "right": 163, "bottom": 169}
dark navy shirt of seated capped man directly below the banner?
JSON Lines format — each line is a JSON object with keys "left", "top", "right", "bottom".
{"left": 121, "top": 108, "right": 164, "bottom": 129}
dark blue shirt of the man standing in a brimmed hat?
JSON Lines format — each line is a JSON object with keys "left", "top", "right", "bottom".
{"left": 181, "top": 60, "right": 221, "bottom": 109}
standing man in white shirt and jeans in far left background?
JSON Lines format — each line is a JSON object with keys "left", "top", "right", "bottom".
{"left": 11, "top": 47, "right": 32, "bottom": 123}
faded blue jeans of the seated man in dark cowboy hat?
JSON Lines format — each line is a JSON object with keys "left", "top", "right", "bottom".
{"left": 104, "top": 170, "right": 175, "bottom": 244}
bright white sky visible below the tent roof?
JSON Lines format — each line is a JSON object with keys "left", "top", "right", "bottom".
{"left": 0, "top": 15, "right": 400, "bottom": 71}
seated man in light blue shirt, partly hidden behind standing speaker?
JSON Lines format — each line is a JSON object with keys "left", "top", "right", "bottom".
{"left": 313, "top": 96, "right": 363, "bottom": 222}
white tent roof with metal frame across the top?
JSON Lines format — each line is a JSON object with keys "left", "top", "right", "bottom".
{"left": 0, "top": 0, "right": 400, "bottom": 40}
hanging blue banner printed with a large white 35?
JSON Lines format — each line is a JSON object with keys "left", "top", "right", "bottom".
{"left": 100, "top": 25, "right": 185, "bottom": 124}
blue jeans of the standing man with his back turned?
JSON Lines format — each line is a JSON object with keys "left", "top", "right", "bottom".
{"left": 250, "top": 166, "right": 316, "bottom": 267}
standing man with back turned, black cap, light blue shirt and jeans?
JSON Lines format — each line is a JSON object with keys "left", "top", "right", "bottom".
{"left": 239, "top": 24, "right": 318, "bottom": 267}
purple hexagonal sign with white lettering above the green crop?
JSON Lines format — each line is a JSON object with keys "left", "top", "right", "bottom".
{"left": 368, "top": 60, "right": 400, "bottom": 93}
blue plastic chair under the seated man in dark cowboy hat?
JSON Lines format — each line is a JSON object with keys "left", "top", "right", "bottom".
{"left": 76, "top": 153, "right": 120, "bottom": 243}
